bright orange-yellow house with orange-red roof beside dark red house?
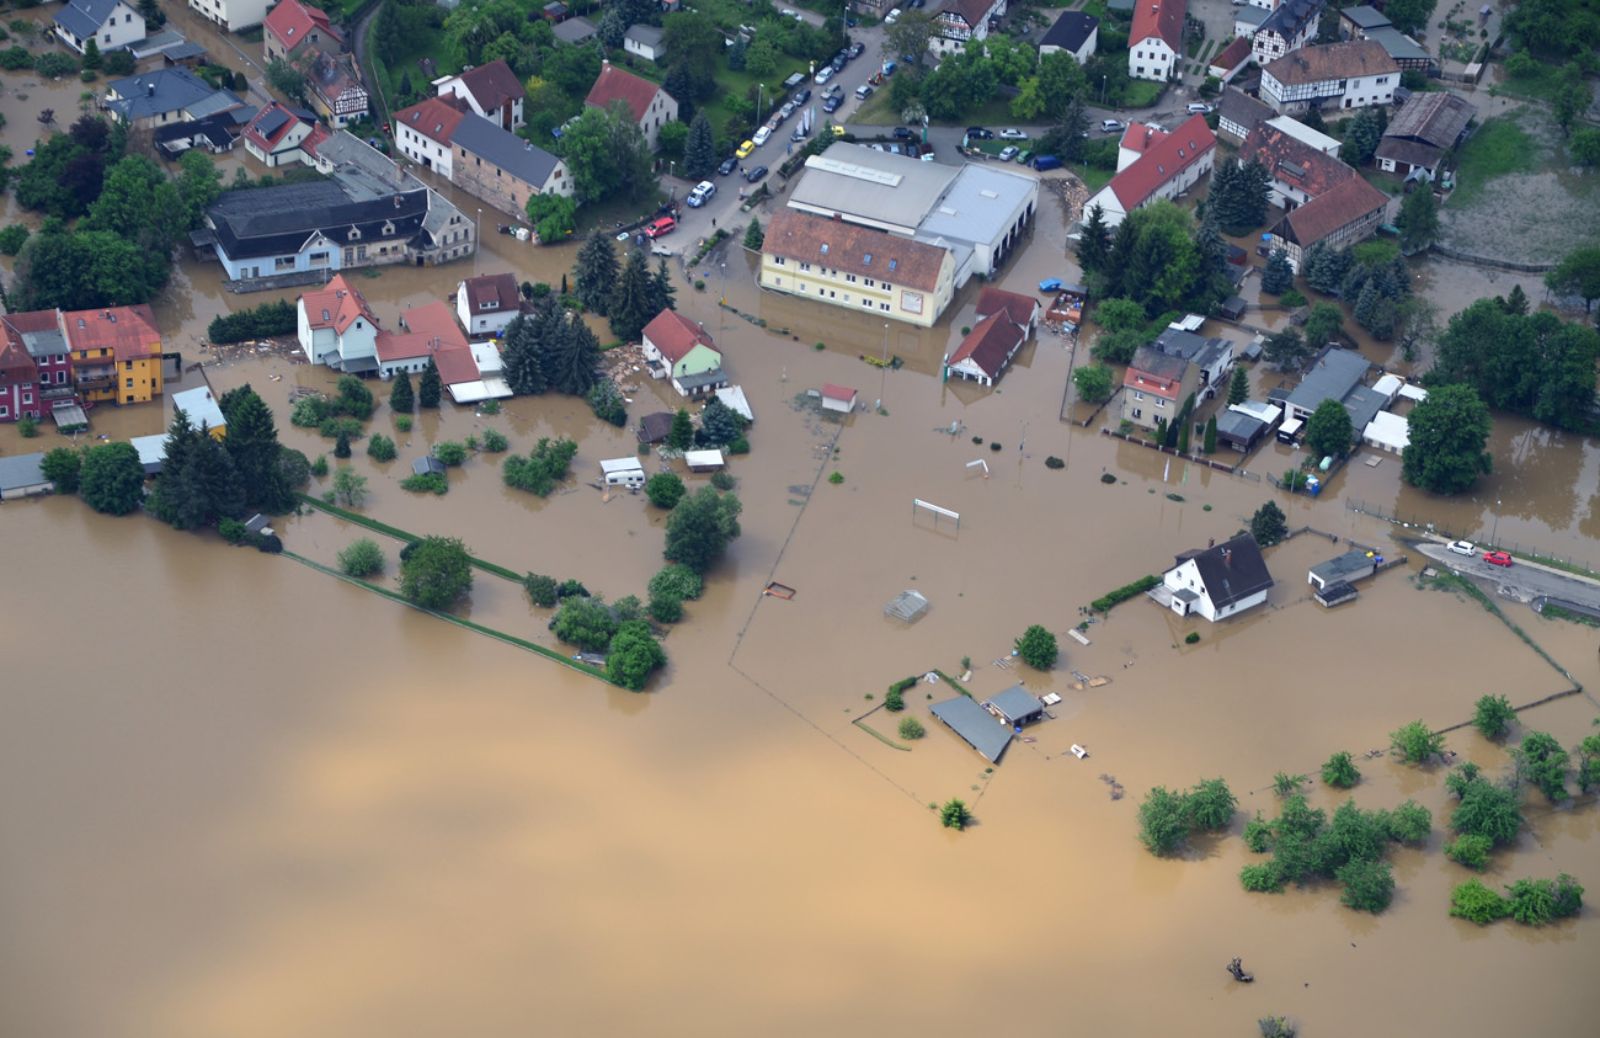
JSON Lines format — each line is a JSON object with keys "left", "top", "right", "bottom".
{"left": 61, "top": 302, "right": 162, "bottom": 405}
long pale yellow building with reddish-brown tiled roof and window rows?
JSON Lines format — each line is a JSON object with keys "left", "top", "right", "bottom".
{"left": 762, "top": 210, "right": 955, "bottom": 328}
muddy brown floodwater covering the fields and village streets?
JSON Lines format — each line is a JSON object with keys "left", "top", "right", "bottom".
{"left": 0, "top": 85, "right": 1600, "bottom": 1038}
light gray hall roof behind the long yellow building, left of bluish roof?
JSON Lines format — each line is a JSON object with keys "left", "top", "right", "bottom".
{"left": 789, "top": 142, "right": 960, "bottom": 227}
